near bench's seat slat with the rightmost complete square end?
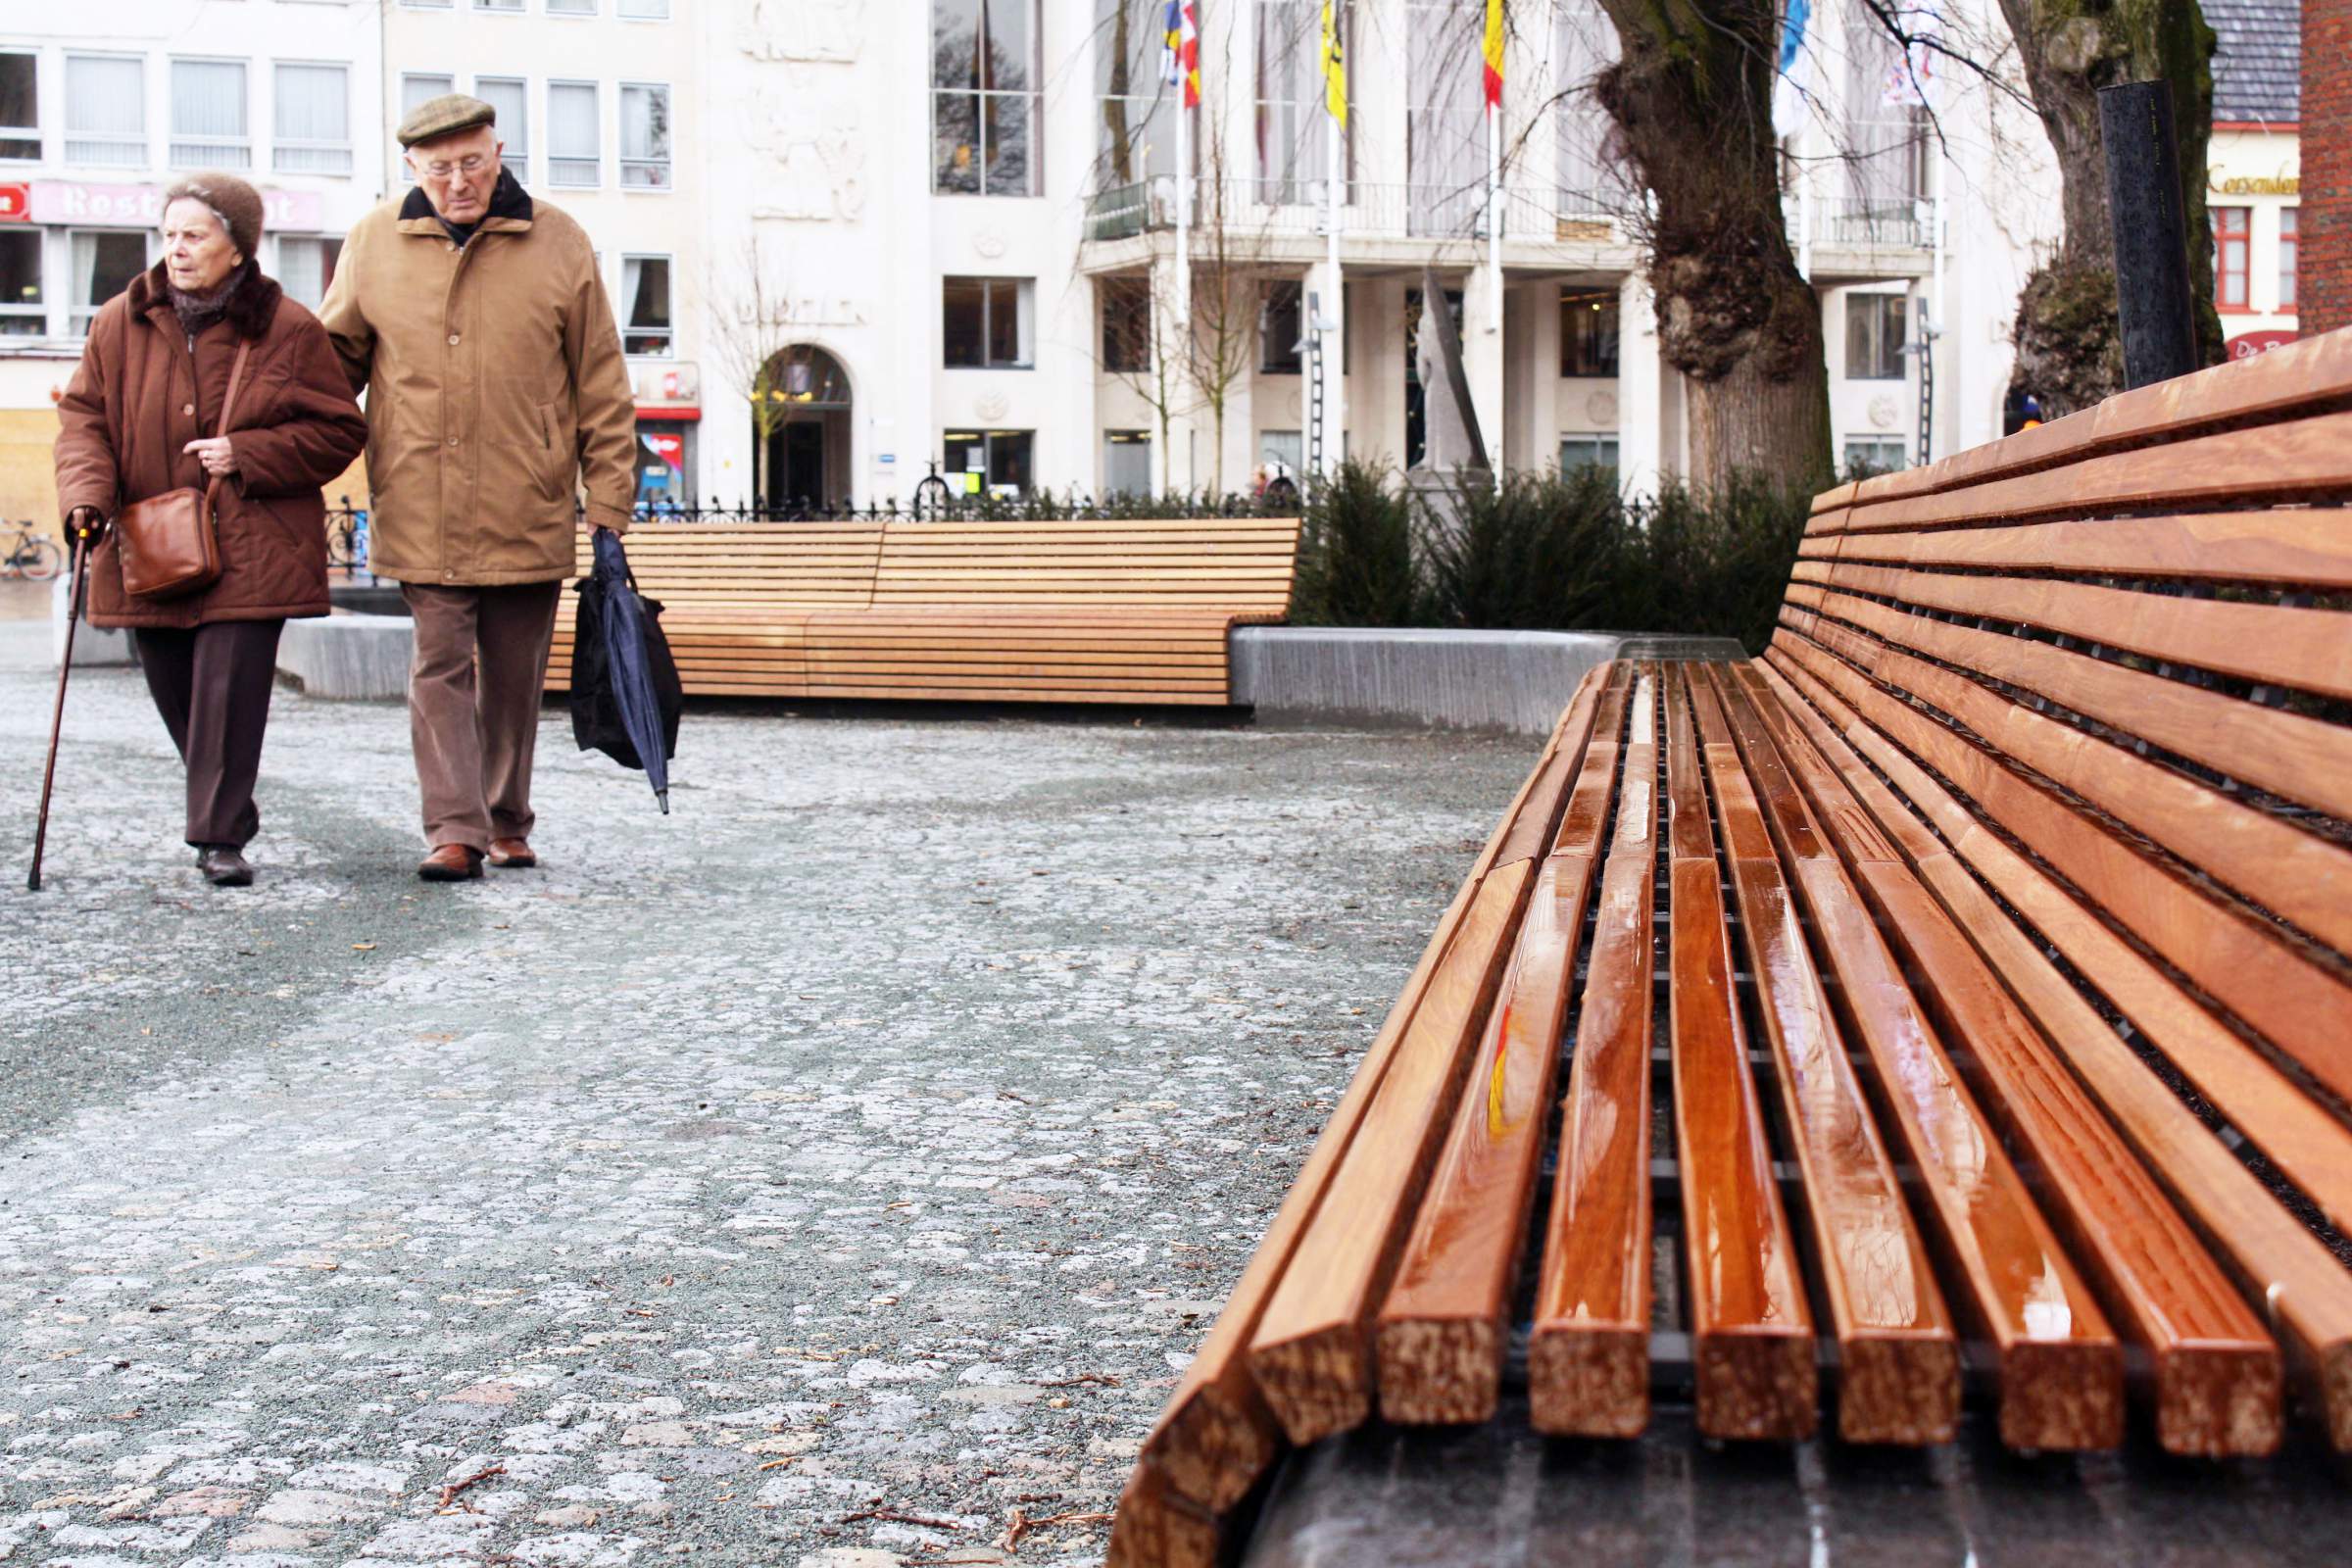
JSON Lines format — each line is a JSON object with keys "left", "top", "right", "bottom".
{"left": 1739, "top": 667, "right": 2281, "bottom": 1455}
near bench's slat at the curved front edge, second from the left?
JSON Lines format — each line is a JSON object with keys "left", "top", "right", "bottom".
{"left": 1141, "top": 665, "right": 1613, "bottom": 1516}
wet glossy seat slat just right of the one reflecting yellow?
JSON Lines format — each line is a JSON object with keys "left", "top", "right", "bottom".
{"left": 1527, "top": 674, "right": 1658, "bottom": 1437}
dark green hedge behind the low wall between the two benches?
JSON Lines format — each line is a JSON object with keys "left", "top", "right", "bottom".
{"left": 1292, "top": 464, "right": 1811, "bottom": 651}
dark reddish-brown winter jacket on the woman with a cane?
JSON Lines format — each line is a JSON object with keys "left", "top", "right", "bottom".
{"left": 57, "top": 264, "right": 367, "bottom": 627}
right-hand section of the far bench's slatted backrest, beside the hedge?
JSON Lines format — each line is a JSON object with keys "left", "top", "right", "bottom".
{"left": 875, "top": 517, "right": 1298, "bottom": 620}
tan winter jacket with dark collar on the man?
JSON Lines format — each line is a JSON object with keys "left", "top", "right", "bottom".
{"left": 319, "top": 174, "right": 637, "bottom": 588}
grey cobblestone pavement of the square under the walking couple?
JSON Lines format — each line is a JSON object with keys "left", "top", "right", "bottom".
{"left": 0, "top": 623, "right": 1534, "bottom": 1568}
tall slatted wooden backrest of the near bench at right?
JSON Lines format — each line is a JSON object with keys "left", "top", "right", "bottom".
{"left": 1769, "top": 331, "right": 2352, "bottom": 1109}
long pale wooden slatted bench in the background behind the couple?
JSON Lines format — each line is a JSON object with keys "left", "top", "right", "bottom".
{"left": 548, "top": 517, "right": 1298, "bottom": 706}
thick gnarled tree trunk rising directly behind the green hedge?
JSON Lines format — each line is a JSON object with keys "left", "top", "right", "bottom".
{"left": 1594, "top": 0, "right": 1830, "bottom": 484}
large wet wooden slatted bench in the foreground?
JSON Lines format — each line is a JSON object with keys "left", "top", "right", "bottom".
{"left": 1110, "top": 331, "right": 2352, "bottom": 1568}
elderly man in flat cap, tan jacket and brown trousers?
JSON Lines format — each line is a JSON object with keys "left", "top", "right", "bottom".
{"left": 319, "top": 94, "right": 637, "bottom": 882}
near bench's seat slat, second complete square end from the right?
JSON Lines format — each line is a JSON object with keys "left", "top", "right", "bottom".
{"left": 1710, "top": 667, "right": 2124, "bottom": 1448}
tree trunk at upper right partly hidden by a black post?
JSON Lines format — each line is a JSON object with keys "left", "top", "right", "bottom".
{"left": 2001, "top": 0, "right": 2223, "bottom": 418}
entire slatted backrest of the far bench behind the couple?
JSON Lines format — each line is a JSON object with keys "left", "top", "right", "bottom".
{"left": 578, "top": 517, "right": 1298, "bottom": 620}
